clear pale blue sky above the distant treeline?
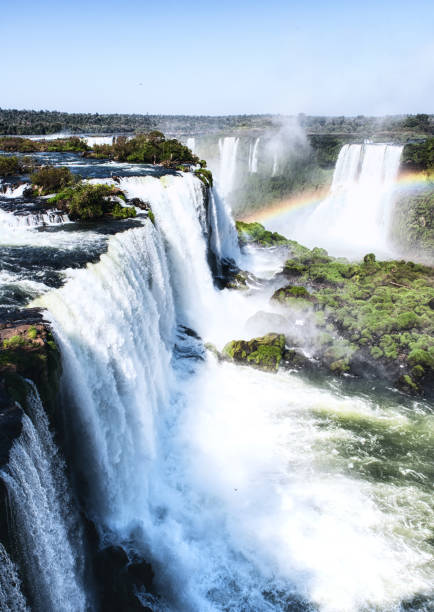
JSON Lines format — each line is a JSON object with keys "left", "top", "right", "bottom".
{"left": 0, "top": 0, "right": 434, "bottom": 115}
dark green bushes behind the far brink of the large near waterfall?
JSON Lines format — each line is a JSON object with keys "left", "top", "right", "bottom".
{"left": 86, "top": 130, "right": 198, "bottom": 166}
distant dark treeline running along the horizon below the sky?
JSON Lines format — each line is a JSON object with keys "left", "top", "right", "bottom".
{"left": 0, "top": 109, "right": 434, "bottom": 140}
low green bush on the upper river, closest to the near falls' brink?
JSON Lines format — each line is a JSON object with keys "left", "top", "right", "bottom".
{"left": 48, "top": 183, "right": 136, "bottom": 220}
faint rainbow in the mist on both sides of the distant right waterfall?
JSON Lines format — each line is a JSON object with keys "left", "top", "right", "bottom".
{"left": 239, "top": 172, "right": 434, "bottom": 223}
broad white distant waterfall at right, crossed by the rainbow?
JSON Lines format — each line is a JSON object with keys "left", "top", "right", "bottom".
{"left": 282, "top": 144, "right": 402, "bottom": 256}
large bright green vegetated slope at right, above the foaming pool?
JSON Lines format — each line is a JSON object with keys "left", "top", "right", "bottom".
{"left": 273, "top": 244, "right": 434, "bottom": 390}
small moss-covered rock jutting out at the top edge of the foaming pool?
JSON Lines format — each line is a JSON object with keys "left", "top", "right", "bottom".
{"left": 223, "top": 333, "right": 285, "bottom": 372}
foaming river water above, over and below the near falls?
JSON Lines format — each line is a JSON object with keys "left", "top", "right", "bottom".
{"left": 0, "top": 149, "right": 434, "bottom": 612}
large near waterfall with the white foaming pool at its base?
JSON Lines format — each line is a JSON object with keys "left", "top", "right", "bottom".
{"left": 32, "top": 176, "right": 430, "bottom": 612}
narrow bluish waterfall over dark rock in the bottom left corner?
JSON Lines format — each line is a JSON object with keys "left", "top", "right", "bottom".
{"left": 0, "top": 381, "right": 86, "bottom": 612}
